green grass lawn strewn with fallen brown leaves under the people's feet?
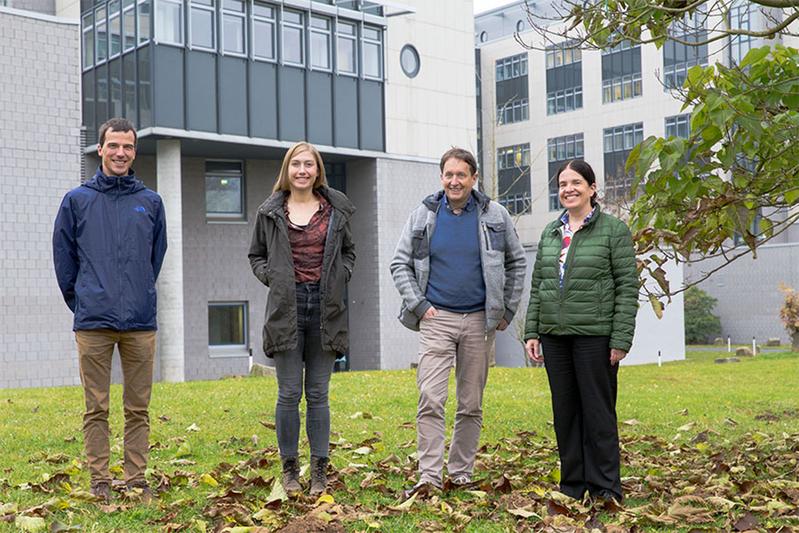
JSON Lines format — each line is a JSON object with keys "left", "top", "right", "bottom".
{"left": 0, "top": 348, "right": 799, "bottom": 532}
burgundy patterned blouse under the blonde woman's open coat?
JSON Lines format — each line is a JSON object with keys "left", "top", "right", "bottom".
{"left": 283, "top": 195, "right": 332, "bottom": 283}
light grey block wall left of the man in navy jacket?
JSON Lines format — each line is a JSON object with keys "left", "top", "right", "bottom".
{"left": 0, "top": 6, "right": 81, "bottom": 388}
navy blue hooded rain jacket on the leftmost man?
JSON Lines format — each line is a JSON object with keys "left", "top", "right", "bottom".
{"left": 53, "top": 168, "right": 166, "bottom": 331}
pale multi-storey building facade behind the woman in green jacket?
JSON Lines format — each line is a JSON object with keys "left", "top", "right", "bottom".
{"left": 475, "top": 0, "right": 799, "bottom": 350}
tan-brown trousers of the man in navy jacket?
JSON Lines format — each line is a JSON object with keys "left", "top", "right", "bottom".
{"left": 75, "top": 329, "right": 156, "bottom": 483}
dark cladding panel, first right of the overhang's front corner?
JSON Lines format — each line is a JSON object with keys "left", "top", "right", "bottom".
{"left": 153, "top": 45, "right": 185, "bottom": 129}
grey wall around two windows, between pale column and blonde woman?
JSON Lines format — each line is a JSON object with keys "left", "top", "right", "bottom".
{"left": 183, "top": 158, "right": 280, "bottom": 381}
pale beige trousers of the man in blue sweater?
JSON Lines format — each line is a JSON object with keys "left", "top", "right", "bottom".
{"left": 416, "top": 310, "right": 496, "bottom": 486}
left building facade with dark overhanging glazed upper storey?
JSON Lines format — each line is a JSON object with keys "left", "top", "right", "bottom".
{"left": 0, "top": 0, "right": 476, "bottom": 386}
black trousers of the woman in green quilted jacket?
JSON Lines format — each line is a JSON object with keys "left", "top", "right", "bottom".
{"left": 541, "top": 335, "right": 622, "bottom": 501}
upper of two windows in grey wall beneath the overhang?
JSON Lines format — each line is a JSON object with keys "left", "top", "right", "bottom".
{"left": 205, "top": 161, "right": 244, "bottom": 218}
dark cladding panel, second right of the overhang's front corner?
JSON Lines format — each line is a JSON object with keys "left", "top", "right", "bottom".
{"left": 186, "top": 51, "right": 217, "bottom": 132}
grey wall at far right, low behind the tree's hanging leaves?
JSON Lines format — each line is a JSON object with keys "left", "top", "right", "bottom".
{"left": 685, "top": 242, "right": 799, "bottom": 344}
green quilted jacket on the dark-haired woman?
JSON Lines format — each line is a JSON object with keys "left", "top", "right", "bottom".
{"left": 524, "top": 206, "right": 639, "bottom": 352}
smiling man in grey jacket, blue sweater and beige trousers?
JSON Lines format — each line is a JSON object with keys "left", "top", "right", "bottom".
{"left": 391, "top": 148, "right": 526, "bottom": 496}
